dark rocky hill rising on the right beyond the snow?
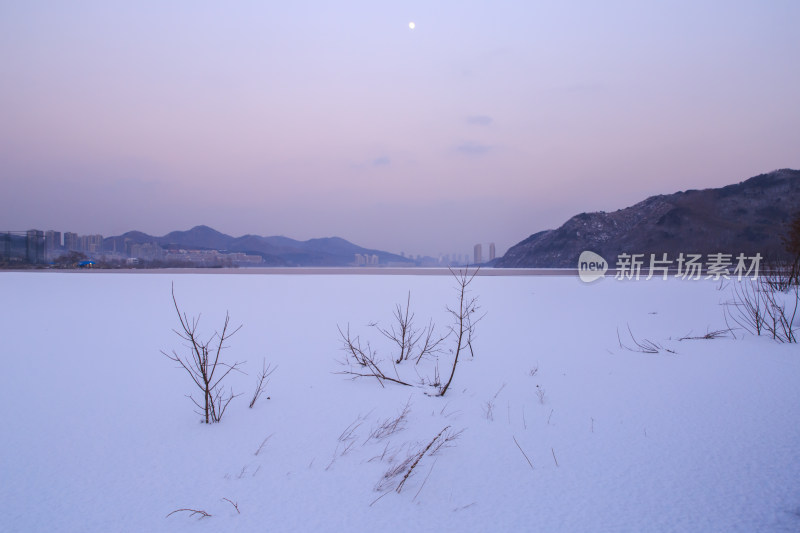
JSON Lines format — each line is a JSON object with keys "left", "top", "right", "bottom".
{"left": 494, "top": 169, "right": 800, "bottom": 268}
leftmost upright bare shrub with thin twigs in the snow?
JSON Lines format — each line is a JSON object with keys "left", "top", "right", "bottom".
{"left": 161, "top": 285, "right": 243, "bottom": 424}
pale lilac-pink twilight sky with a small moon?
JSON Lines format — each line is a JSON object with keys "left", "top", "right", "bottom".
{"left": 0, "top": 0, "right": 800, "bottom": 256}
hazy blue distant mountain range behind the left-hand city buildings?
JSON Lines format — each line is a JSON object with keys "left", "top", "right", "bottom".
{"left": 103, "top": 226, "right": 413, "bottom": 266}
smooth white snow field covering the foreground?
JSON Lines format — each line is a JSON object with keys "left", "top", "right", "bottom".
{"left": 0, "top": 272, "right": 800, "bottom": 532}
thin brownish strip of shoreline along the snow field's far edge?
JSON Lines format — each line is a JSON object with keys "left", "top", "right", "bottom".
{"left": 0, "top": 267, "right": 578, "bottom": 276}
